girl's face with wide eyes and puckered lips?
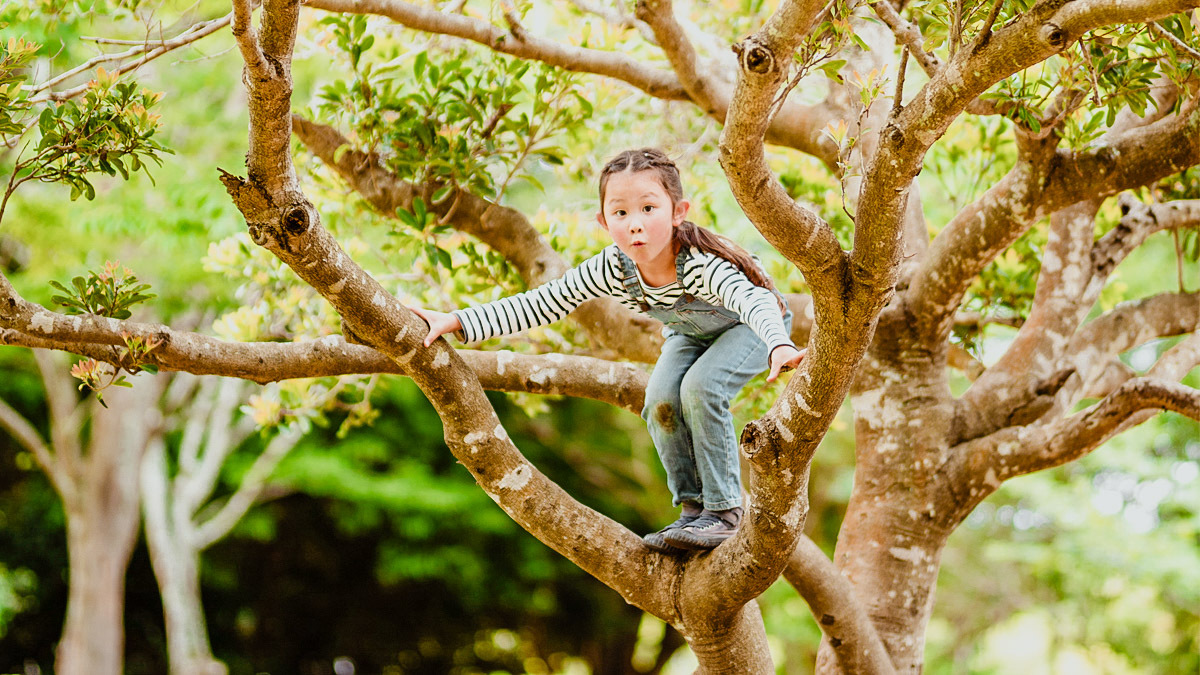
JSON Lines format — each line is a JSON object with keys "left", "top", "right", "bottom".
{"left": 596, "top": 169, "right": 690, "bottom": 269}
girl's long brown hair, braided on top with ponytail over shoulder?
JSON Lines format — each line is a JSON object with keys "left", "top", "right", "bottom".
{"left": 600, "top": 148, "right": 775, "bottom": 291}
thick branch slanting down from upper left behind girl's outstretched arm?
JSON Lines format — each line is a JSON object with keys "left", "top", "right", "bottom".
{"left": 293, "top": 117, "right": 662, "bottom": 363}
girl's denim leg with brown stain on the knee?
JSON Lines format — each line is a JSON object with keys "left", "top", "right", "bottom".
{"left": 642, "top": 334, "right": 704, "bottom": 506}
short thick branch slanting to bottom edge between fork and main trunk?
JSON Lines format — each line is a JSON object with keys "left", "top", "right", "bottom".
{"left": 784, "top": 533, "right": 895, "bottom": 675}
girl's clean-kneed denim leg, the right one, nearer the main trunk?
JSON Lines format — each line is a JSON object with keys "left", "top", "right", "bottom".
{"left": 680, "top": 324, "right": 768, "bottom": 510}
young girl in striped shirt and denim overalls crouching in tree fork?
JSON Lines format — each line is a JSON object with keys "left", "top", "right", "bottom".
{"left": 413, "top": 148, "right": 804, "bottom": 551}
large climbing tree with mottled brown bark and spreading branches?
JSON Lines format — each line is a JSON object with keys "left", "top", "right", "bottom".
{"left": 0, "top": 0, "right": 1200, "bottom": 673}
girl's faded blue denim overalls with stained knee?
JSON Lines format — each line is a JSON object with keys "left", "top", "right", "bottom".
{"left": 620, "top": 249, "right": 792, "bottom": 510}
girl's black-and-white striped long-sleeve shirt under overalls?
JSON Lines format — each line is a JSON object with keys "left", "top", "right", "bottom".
{"left": 452, "top": 244, "right": 794, "bottom": 353}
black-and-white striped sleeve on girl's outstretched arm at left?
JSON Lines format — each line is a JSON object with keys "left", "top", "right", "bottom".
{"left": 451, "top": 251, "right": 612, "bottom": 342}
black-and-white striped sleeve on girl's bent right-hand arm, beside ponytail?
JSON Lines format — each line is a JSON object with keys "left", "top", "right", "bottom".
{"left": 696, "top": 256, "right": 796, "bottom": 353}
